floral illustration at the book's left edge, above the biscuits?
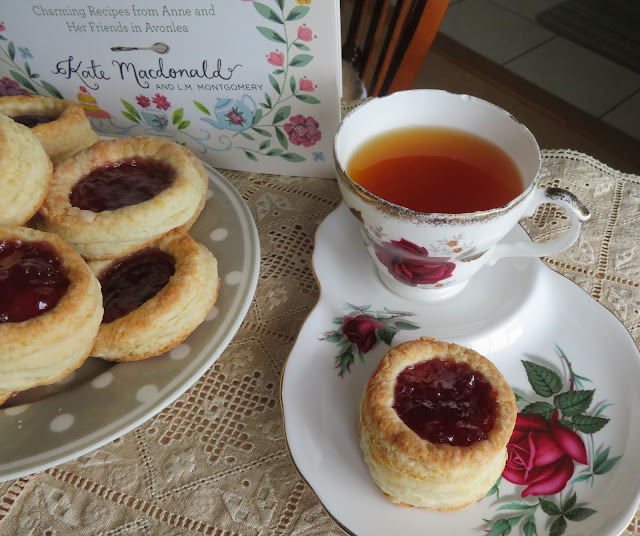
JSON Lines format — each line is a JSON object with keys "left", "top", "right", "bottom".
{"left": 0, "top": 22, "right": 63, "bottom": 99}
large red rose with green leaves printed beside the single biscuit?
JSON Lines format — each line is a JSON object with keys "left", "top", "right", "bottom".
{"left": 483, "top": 345, "right": 622, "bottom": 536}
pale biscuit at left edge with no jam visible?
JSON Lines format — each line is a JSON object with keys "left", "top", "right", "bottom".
{"left": 0, "top": 115, "right": 52, "bottom": 225}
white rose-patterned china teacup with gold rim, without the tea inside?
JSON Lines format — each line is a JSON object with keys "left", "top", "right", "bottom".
{"left": 334, "top": 90, "right": 590, "bottom": 302}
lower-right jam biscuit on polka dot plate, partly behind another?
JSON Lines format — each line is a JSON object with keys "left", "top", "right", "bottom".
{"left": 89, "top": 231, "right": 220, "bottom": 361}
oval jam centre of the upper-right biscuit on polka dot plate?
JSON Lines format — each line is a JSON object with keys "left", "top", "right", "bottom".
{"left": 69, "top": 158, "right": 175, "bottom": 212}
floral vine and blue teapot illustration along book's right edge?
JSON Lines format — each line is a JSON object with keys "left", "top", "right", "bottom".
{"left": 193, "top": 0, "right": 324, "bottom": 162}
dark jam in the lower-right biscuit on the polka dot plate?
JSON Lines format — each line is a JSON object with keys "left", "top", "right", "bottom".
{"left": 99, "top": 248, "right": 176, "bottom": 324}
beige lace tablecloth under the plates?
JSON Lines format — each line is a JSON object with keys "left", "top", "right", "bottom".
{"left": 0, "top": 139, "right": 640, "bottom": 536}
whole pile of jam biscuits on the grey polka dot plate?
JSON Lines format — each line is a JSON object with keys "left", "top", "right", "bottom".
{"left": 0, "top": 96, "right": 219, "bottom": 404}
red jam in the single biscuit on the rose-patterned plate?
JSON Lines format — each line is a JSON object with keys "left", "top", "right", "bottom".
{"left": 393, "top": 358, "right": 498, "bottom": 447}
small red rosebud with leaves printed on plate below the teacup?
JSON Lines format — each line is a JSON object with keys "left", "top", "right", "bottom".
{"left": 320, "top": 303, "right": 420, "bottom": 377}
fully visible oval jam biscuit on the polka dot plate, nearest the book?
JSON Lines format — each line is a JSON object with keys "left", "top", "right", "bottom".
{"left": 40, "top": 136, "right": 207, "bottom": 260}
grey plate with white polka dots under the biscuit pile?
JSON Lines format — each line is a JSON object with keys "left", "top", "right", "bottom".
{"left": 0, "top": 164, "right": 260, "bottom": 481}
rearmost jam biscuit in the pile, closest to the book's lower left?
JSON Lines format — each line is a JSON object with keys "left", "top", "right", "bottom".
{"left": 0, "top": 95, "right": 98, "bottom": 165}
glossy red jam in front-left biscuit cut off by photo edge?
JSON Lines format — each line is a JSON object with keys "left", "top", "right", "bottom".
{"left": 0, "top": 239, "right": 69, "bottom": 324}
